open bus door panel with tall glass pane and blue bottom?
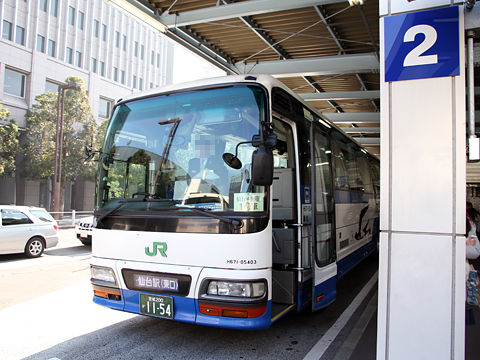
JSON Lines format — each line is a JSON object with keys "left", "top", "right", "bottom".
{"left": 310, "top": 123, "right": 337, "bottom": 311}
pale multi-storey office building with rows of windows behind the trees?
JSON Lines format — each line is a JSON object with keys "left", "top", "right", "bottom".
{"left": 0, "top": 0, "right": 173, "bottom": 211}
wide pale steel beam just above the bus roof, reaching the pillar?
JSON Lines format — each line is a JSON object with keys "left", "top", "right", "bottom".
{"left": 235, "top": 54, "right": 380, "bottom": 77}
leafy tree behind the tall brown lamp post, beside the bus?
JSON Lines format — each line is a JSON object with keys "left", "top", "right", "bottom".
{"left": 22, "top": 76, "right": 96, "bottom": 211}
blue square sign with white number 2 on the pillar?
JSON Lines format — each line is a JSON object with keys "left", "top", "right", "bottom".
{"left": 384, "top": 6, "right": 460, "bottom": 82}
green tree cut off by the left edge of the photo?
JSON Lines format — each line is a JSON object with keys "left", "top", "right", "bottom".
{"left": 0, "top": 104, "right": 19, "bottom": 179}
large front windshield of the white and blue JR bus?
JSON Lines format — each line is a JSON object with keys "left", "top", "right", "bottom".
{"left": 95, "top": 85, "right": 267, "bottom": 212}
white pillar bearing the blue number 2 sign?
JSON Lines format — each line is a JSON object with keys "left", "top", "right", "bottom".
{"left": 377, "top": 0, "right": 466, "bottom": 360}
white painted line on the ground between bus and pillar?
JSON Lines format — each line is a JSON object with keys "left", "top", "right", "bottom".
{"left": 303, "top": 271, "right": 378, "bottom": 360}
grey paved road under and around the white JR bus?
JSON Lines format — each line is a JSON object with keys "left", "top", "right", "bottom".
{"left": 0, "top": 230, "right": 378, "bottom": 360}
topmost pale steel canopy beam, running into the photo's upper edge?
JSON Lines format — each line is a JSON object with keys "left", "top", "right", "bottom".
{"left": 160, "top": 0, "right": 346, "bottom": 28}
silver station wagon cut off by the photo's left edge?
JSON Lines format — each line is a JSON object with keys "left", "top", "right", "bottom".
{"left": 0, "top": 205, "right": 58, "bottom": 257}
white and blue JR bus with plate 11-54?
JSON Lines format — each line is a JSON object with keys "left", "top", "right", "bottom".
{"left": 91, "top": 75, "right": 380, "bottom": 329}
